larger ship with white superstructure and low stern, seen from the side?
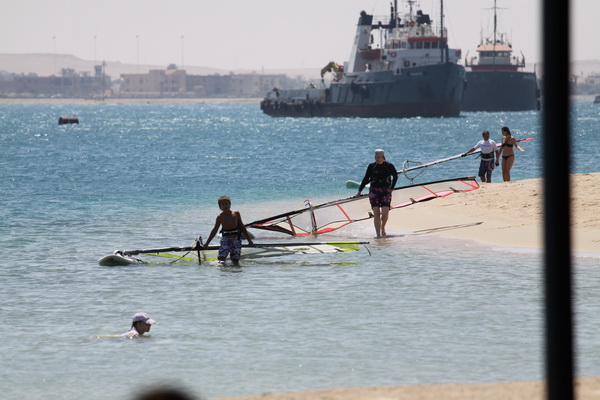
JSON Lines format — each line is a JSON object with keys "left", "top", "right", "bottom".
{"left": 260, "top": 0, "right": 465, "bottom": 118}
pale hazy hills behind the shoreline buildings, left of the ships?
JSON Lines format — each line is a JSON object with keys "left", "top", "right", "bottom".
{"left": 0, "top": 54, "right": 320, "bottom": 79}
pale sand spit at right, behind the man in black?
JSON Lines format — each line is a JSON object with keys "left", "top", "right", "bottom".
{"left": 388, "top": 173, "right": 600, "bottom": 253}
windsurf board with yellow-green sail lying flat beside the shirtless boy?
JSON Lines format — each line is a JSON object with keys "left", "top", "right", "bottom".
{"left": 98, "top": 241, "right": 369, "bottom": 266}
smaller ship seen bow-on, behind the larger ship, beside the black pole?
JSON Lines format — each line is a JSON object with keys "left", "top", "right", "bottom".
{"left": 461, "top": 0, "right": 540, "bottom": 111}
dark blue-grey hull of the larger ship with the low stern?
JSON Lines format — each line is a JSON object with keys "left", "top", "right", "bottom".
{"left": 261, "top": 63, "right": 465, "bottom": 118}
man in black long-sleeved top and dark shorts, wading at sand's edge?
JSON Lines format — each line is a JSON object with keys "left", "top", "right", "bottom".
{"left": 355, "top": 149, "right": 398, "bottom": 237}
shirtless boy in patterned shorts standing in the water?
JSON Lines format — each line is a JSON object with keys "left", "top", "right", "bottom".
{"left": 204, "top": 196, "right": 254, "bottom": 265}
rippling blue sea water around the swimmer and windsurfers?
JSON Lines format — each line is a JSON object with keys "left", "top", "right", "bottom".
{"left": 0, "top": 102, "right": 600, "bottom": 399}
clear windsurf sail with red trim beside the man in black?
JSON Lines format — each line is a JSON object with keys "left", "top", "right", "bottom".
{"left": 246, "top": 177, "right": 479, "bottom": 236}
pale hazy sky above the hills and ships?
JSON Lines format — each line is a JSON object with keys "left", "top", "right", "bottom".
{"left": 0, "top": 0, "right": 600, "bottom": 71}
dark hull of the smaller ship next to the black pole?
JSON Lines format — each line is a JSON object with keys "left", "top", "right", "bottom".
{"left": 461, "top": 71, "right": 540, "bottom": 111}
